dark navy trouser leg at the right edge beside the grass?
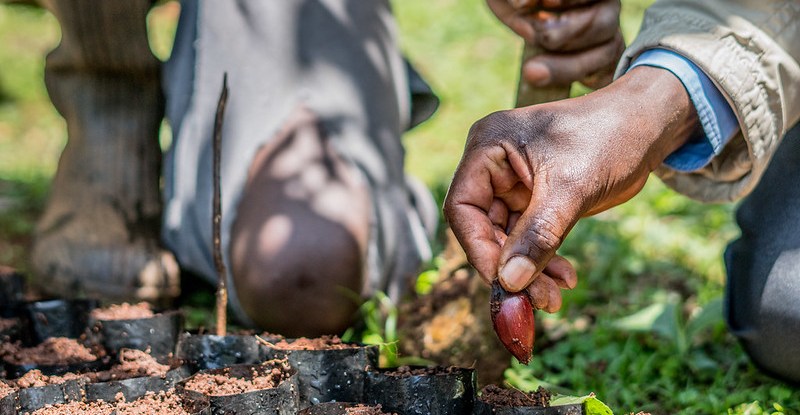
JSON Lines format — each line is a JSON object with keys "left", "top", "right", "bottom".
{"left": 725, "top": 125, "right": 800, "bottom": 382}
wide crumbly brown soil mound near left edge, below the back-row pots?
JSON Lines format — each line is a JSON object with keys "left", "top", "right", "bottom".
{"left": 0, "top": 337, "right": 97, "bottom": 366}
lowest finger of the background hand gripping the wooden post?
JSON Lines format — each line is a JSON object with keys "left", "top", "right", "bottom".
{"left": 522, "top": 32, "right": 622, "bottom": 87}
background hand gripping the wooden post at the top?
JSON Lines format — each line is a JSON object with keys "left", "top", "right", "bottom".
{"left": 487, "top": 0, "right": 625, "bottom": 88}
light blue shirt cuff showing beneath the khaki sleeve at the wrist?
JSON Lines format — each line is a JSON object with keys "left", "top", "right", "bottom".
{"left": 628, "top": 49, "right": 739, "bottom": 172}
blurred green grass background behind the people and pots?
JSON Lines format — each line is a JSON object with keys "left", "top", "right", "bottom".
{"left": 0, "top": 0, "right": 800, "bottom": 414}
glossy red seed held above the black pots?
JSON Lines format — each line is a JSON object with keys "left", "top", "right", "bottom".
{"left": 489, "top": 280, "right": 536, "bottom": 364}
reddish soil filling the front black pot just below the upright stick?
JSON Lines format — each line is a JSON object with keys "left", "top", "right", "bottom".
{"left": 186, "top": 360, "right": 291, "bottom": 396}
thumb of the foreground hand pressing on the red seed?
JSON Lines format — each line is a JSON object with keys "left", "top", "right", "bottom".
{"left": 497, "top": 191, "right": 580, "bottom": 292}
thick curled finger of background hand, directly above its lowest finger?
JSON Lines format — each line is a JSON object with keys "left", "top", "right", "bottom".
{"left": 530, "top": 0, "right": 620, "bottom": 52}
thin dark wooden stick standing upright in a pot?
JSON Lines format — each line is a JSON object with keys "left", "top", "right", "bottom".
{"left": 212, "top": 72, "right": 228, "bottom": 336}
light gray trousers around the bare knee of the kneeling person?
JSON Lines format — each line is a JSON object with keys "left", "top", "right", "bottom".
{"left": 162, "top": 0, "right": 438, "bottom": 324}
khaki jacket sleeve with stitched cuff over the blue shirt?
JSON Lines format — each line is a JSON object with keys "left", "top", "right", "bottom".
{"left": 617, "top": 0, "right": 800, "bottom": 202}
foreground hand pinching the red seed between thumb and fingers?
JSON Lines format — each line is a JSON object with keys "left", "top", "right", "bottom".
{"left": 444, "top": 67, "right": 698, "bottom": 312}
